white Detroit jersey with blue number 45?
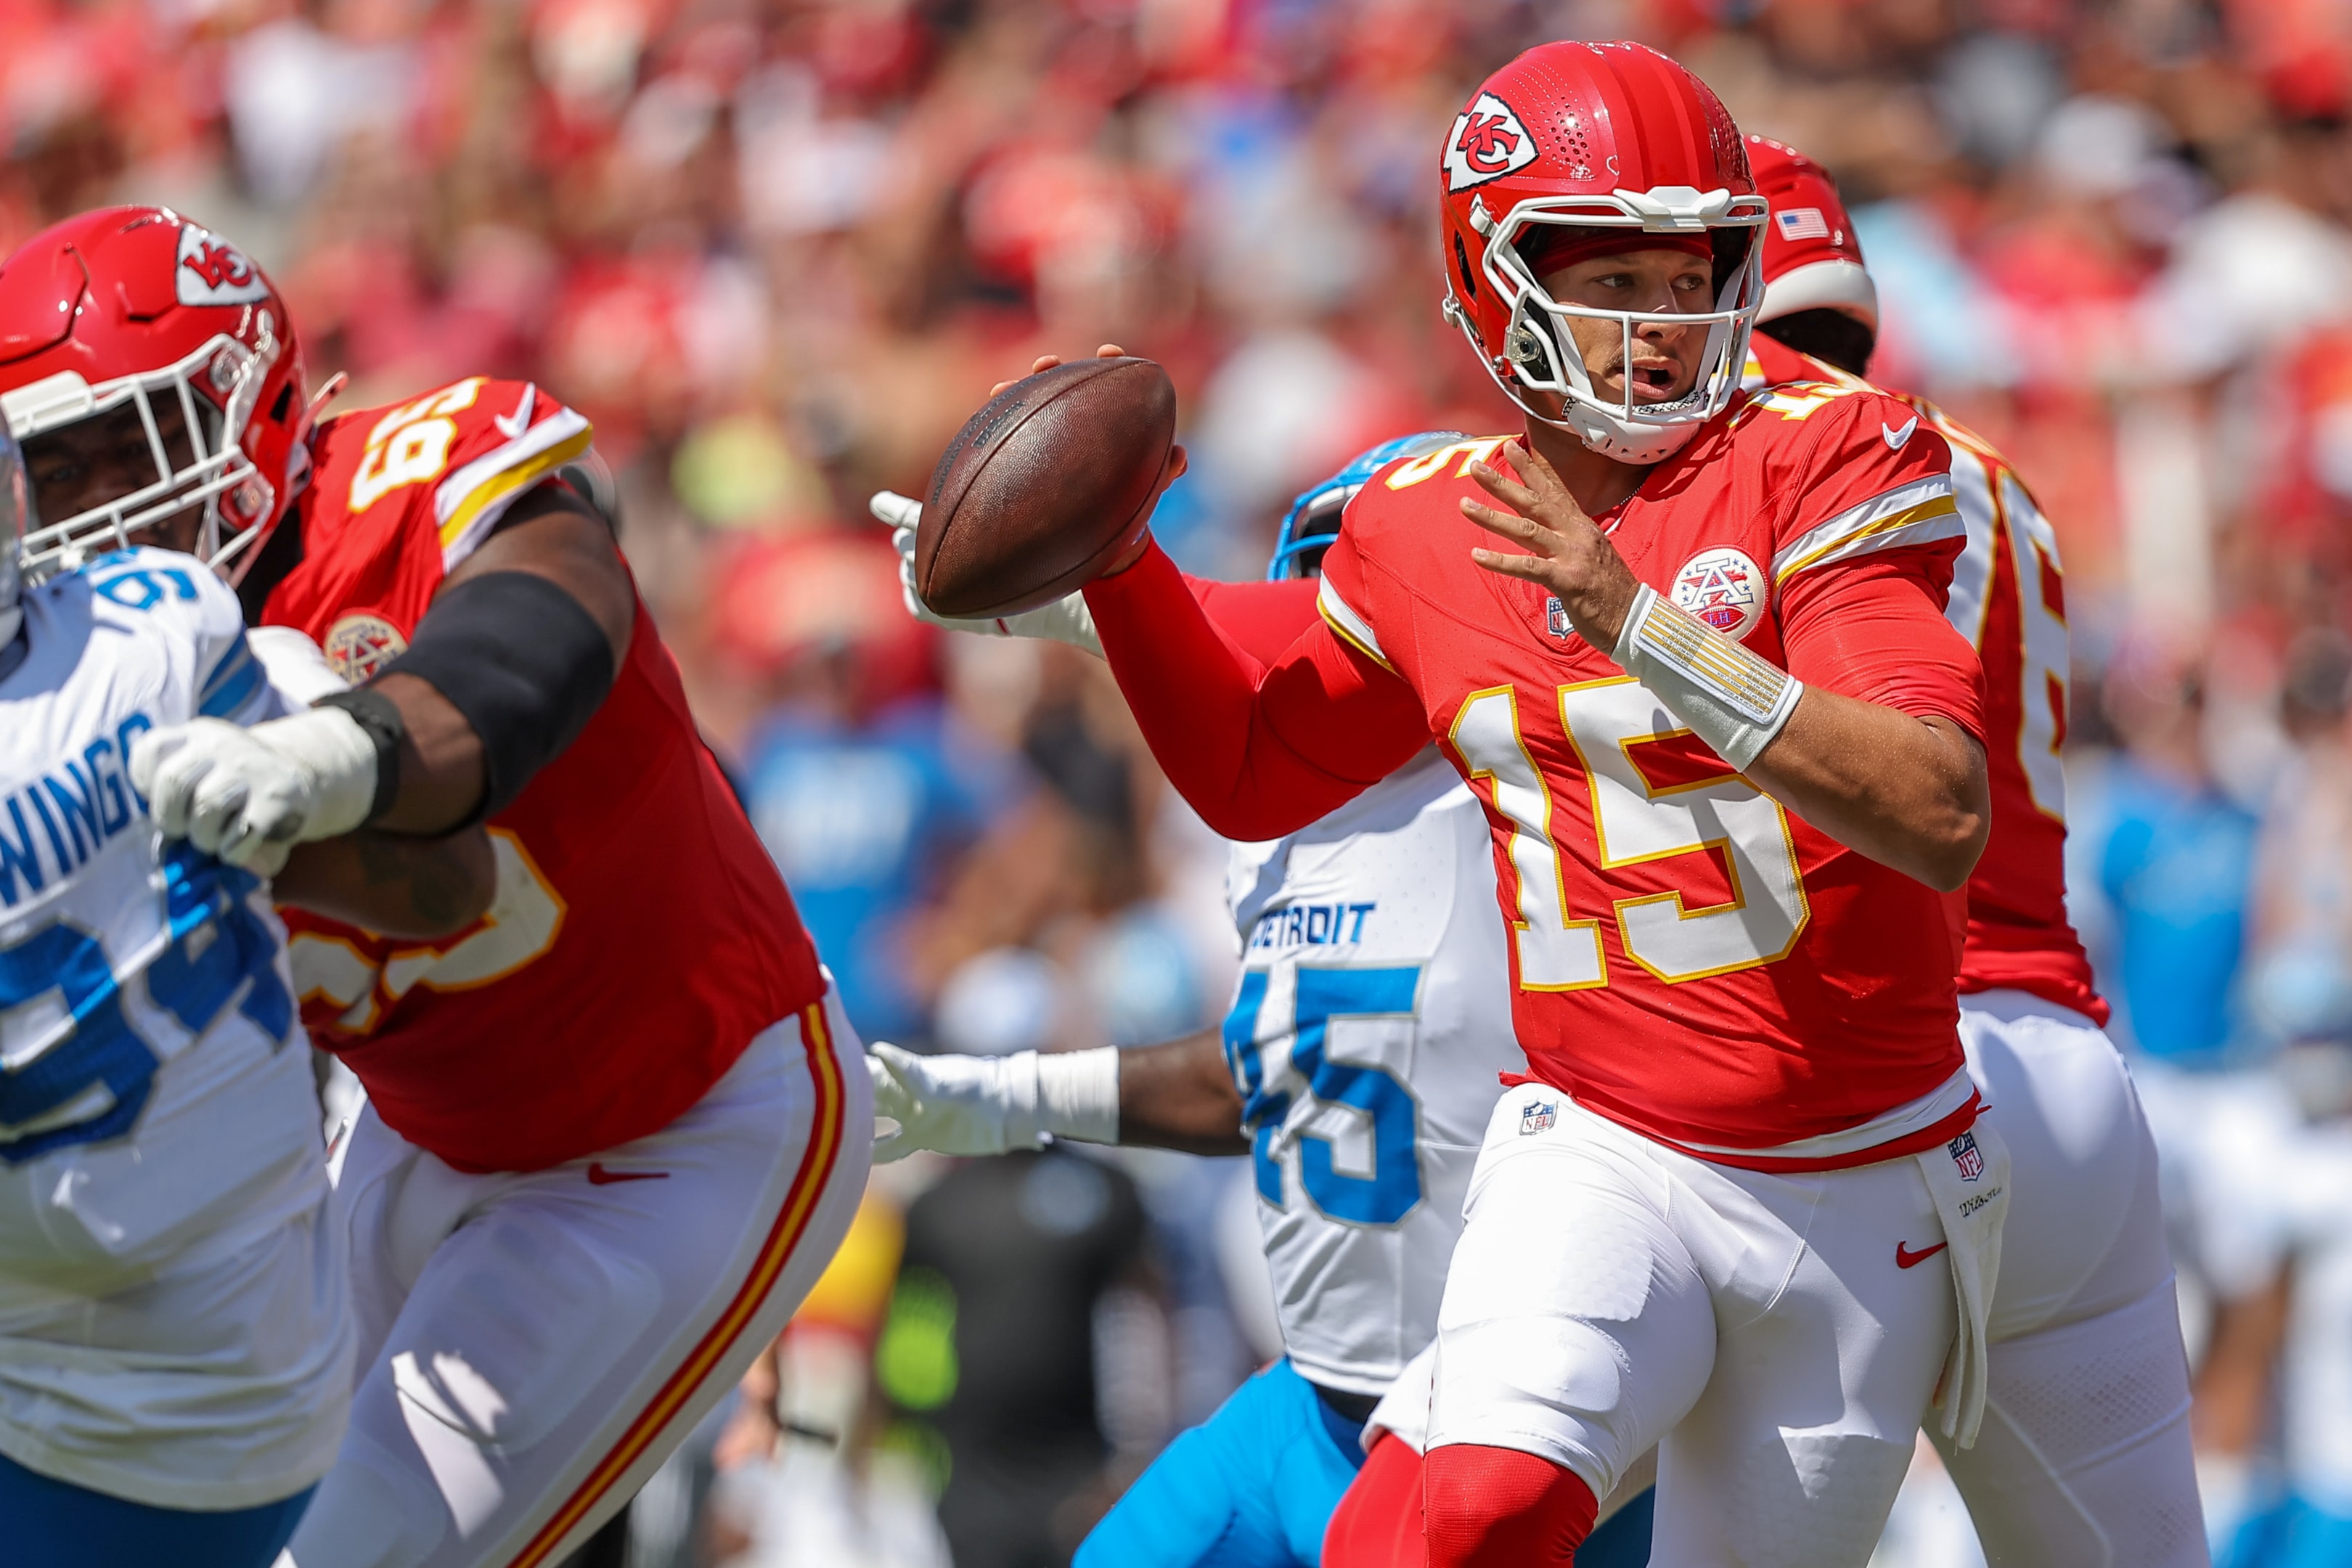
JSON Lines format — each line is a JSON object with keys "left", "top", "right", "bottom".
{"left": 1225, "top": 750, "right": 1527, "bottom": 1394}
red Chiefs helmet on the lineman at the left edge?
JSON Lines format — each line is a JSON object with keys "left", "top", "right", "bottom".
{"left": 0, "top": 207, "right": 311, "bottom": 583}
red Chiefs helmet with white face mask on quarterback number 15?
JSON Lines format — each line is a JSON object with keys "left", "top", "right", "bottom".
{"left": 1440, "top": 42, "right": 1766, "bottom": 463}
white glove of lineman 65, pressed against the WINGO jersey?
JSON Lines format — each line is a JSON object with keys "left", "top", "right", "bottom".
{"left": 129, "top": 708, "right": 376, "bottom": 877}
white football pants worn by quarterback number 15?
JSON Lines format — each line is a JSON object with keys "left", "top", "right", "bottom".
{"left": 1430, "top": 1084, "right": 1957, "bottom": 1568}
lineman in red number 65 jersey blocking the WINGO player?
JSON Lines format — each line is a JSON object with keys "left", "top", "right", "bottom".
{"left": 0, "top": 209, "right": 870, "bottom": 1568}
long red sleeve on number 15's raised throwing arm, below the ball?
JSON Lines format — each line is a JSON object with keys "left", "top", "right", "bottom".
{"left": 1087, "top": 545, "right": 1430, "bottom": 839}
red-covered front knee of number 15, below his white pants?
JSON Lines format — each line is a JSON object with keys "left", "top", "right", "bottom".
{"left": 1421, "top": 1443, "right": 1599, "bottom": 1568}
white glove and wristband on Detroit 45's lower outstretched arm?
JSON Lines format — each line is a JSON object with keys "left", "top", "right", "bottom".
{"left": 865, "top": 1039, "right": 1119, "bottom": 1164}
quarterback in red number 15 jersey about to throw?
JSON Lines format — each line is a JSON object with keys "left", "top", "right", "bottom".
{"left": 1063, "top": 45, "right": 2006, "bottom": 1566}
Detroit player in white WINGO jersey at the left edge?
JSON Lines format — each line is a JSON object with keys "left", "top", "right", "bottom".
{"left": 0, "top": 430, "right": 351, "bottom": 1568}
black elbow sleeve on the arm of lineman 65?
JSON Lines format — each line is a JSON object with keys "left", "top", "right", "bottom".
{"left": 376, "top": 571, "right": 614, "bottom": 822}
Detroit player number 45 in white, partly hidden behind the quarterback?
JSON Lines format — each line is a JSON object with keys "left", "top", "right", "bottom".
{"left": 873, "top": 433, "right": 1524, "bottom": 1568}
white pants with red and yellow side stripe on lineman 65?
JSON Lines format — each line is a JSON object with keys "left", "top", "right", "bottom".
{"left": 277, "top": 992, "right": 873, "bottom": 1568}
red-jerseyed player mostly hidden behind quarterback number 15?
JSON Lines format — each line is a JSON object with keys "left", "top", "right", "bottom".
{"left": 1747, "top": 136, "right": 2206, "bottom": 1568}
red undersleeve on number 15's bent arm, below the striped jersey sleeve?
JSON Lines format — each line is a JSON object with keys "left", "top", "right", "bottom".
{"left": 1781, "top": 541, "right": 1985, "bottom": 743}
